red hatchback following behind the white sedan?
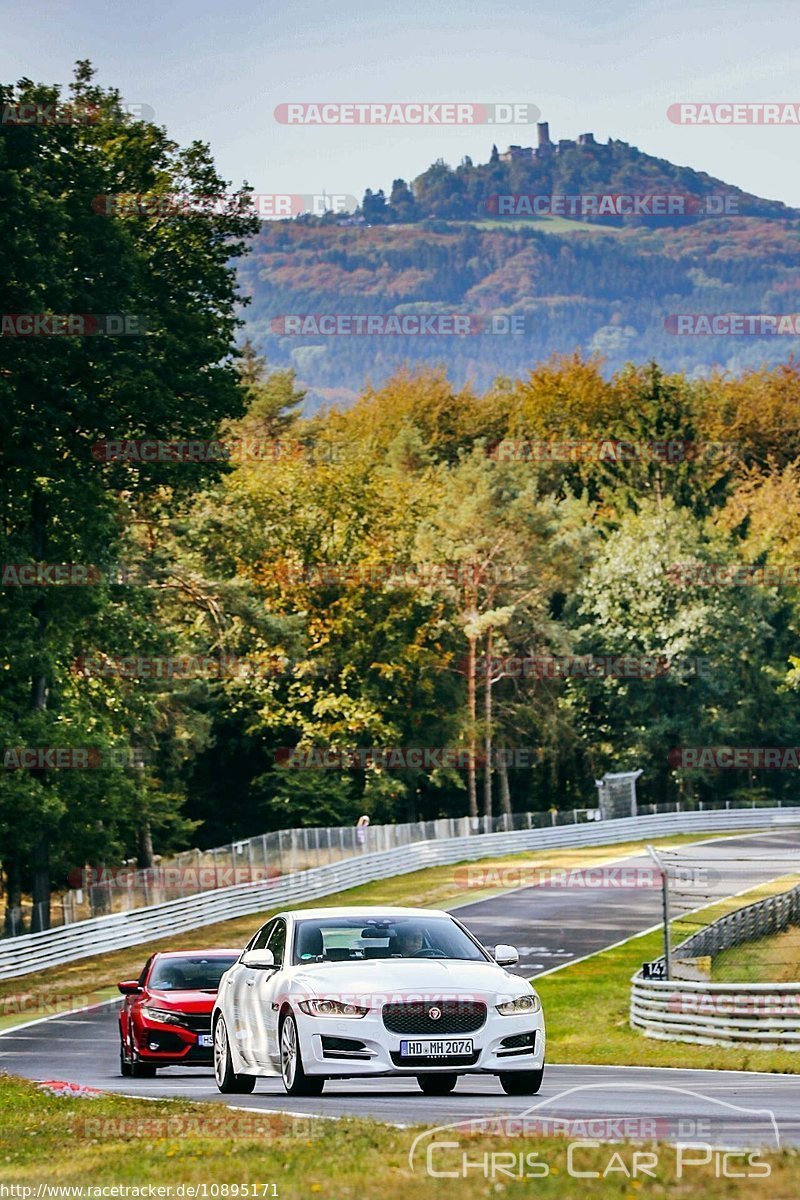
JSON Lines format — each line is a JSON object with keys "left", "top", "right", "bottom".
{"left": 118, "top": 950, "right": 241, "bottom": 1079}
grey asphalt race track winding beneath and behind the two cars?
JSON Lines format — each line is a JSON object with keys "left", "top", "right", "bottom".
{"left": 0, "top": 829, "right": 800, "bottom": 1146}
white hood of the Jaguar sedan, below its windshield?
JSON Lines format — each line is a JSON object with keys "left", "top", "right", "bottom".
{"left": 293, "top": 959, "right": 530, "bottom": 1007}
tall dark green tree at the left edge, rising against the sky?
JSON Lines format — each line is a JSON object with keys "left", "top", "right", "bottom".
{"left": 0, "top": 62, "right": 257, "bottom": 929}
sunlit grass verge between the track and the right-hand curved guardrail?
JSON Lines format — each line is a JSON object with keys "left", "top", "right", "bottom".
{"left": 535, "top": 877, "right": 800, "bottom": 1073}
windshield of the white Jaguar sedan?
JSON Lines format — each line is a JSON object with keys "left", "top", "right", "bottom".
{"left": 293, "top": 917, "right": 487, "bottom": 964}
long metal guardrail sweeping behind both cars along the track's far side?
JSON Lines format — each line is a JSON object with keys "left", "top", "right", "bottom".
{"left": 0, "top": 809, "right": 800, "bottom": 979}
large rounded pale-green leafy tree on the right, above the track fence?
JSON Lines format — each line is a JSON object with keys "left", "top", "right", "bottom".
{"left": 565, "top": 498, "right": 795, "bottom": 803}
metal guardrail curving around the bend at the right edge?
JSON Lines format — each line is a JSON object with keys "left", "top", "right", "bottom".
{"left": 631, "top": 886, "right": 800, "bottom": 1050}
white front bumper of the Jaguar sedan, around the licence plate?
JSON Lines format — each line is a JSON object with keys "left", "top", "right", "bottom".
{"left": 294, "top": 1009, "right": 545, "bottom": 1078}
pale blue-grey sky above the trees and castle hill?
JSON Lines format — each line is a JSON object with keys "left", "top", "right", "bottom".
{"left": 0, "top": 0, "right": 800, "bottom": 206}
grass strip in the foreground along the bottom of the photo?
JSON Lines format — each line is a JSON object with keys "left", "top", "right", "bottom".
{"left": 0, "top": 1078, "right": 800, "bottom": 1200}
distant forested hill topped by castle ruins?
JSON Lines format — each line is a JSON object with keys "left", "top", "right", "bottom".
{"left": 240, "top": 134, "right": 800, "bottom": 407}
